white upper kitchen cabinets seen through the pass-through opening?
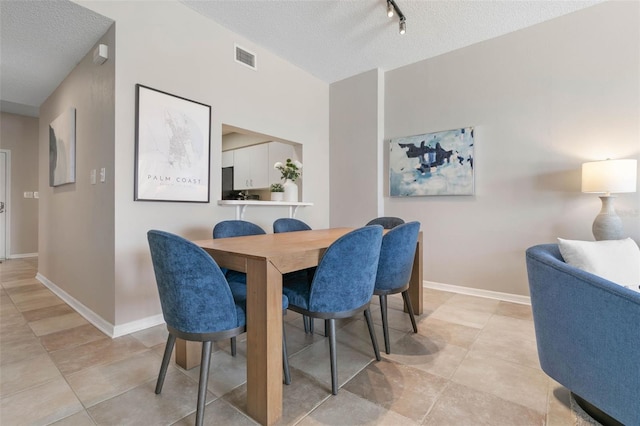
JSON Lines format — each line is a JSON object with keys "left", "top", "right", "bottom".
{"left": 234, "top": 142, "right": 294, "bottom": 191}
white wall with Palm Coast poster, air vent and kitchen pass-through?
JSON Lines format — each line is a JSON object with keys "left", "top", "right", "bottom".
{"left": 78, "top": 1, "right": 329, "bottom": 325}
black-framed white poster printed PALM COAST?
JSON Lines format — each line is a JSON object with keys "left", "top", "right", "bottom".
{"left": 133, "top": 84, "right": 211, "bottom": 203}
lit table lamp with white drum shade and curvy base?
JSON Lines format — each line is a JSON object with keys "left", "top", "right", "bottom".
{"left": 582, "top": 160, "right": 638, "bottom": 241}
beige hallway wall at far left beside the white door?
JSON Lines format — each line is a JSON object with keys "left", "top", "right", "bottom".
{"left": 0, "top": 112, "right": 39, "bottom": 257}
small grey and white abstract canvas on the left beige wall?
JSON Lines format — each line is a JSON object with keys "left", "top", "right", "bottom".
{"left": 49, "top": 108, "right": 76, "bottom": 186}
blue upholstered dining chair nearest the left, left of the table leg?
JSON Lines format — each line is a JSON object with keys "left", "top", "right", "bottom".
{"left": 147, "top": 230, "right": 246, "bottom": 425}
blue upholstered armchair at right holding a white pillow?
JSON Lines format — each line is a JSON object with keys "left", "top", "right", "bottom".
{"left": 526, "top": 244, "right": 640, "bottom": 425}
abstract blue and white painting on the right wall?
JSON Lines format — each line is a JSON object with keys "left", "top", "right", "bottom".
{"left": 389, "top": 127, "right": 474, "bottom": 197}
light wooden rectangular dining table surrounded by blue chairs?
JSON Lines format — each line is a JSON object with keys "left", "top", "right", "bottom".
{"left": 176, "top": 228, "right": 423, "bottom": 425}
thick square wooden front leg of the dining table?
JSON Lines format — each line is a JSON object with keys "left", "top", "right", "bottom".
{"left": 247, "top": 259, "right": 282, "bottom": 425}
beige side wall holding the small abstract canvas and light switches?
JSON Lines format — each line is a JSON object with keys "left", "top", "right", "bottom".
{"left": 38, "top": 26, "right": 116, "bottom": 323}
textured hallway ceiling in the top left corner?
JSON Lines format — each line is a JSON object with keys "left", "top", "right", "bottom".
{"left": 0, "top": 0, "right": 113, "bottom": 115}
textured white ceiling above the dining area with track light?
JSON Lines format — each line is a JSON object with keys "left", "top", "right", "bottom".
{"left": 180, "top": 0, "right": 599, "bottom": 83}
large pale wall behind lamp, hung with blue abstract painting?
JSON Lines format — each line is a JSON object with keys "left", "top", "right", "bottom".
{"left": 385, "top": 2, "right": 640, "bottom": 295}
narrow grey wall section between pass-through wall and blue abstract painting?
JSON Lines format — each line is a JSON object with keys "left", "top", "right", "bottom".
{"left": 330, "top": 69, "right": 384, "bottom": 227}
